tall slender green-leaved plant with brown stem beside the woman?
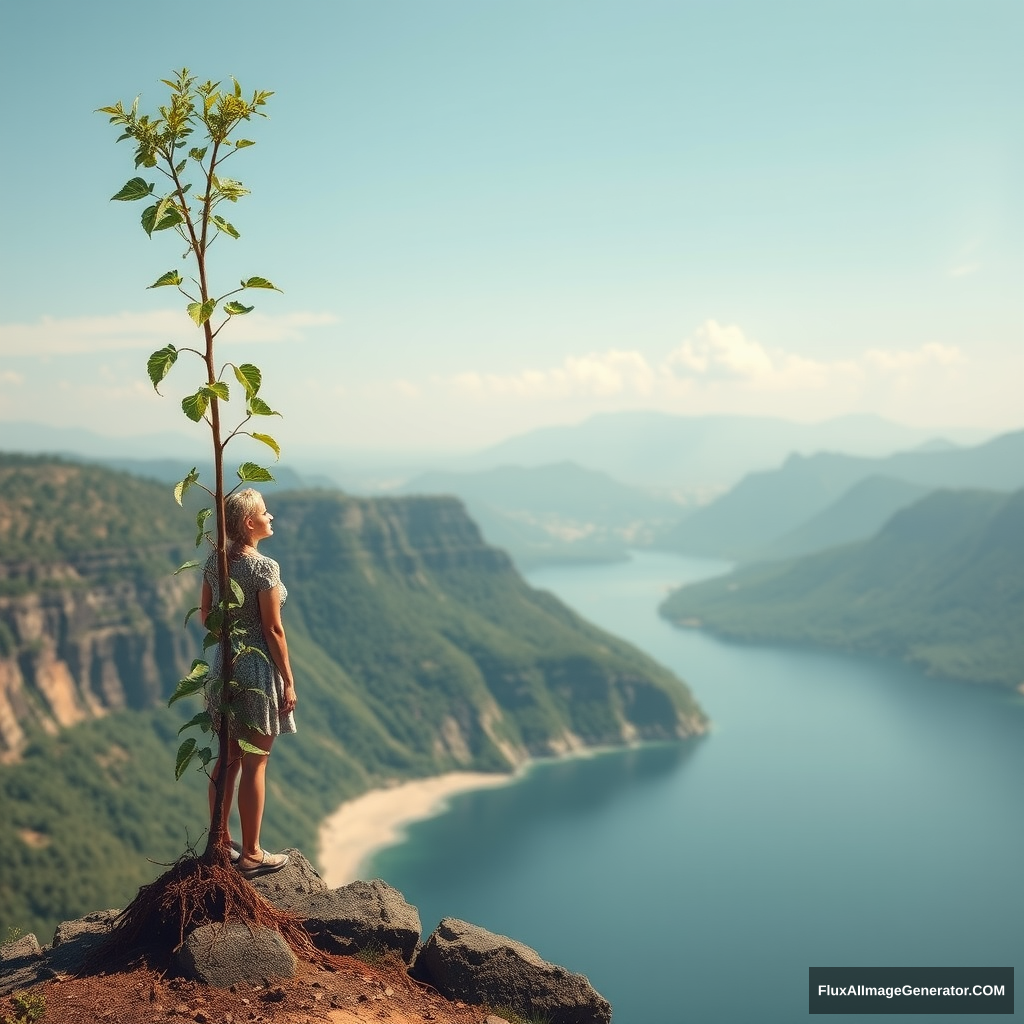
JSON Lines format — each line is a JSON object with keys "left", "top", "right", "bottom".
{"left": 99, "top": 69, "right": 281, "bottom": 860}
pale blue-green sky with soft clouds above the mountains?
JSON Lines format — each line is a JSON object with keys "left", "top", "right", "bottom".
{"left": 0, "top": 0, "right": 1024, "bottom": 451}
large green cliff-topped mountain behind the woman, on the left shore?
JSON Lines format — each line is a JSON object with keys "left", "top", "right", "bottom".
{"left": 0, "top": 456, "right": 706, "bottom": 934}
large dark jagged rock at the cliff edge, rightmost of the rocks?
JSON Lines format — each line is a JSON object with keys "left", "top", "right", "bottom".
{"left": 413, "top": 918, "right": 611, "bottom": 1024}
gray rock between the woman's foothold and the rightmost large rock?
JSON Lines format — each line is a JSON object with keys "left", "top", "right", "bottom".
{"left": 293, "top": 879, "right": 420, "bottom": 964}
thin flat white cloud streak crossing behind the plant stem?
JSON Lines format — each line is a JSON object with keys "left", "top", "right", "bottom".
{"left": 0, "top": 309, "right": 337, "bottom": 356}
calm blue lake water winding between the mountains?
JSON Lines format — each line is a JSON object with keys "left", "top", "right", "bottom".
{"left": 371, "top": 554, "right": 1024, "bottom": 1024}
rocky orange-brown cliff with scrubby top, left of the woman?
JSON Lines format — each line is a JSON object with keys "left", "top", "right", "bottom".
{"left": 0, "top": 455, "right": 195, "bottom": 762}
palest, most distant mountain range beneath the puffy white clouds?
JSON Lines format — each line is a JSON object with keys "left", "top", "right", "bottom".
{"left": 459, "top": 412, "right": 986, "bottom": 489}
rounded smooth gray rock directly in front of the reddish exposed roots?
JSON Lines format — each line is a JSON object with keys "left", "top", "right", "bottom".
{"left": 174, "top": 922, "right": 298, "bottom": 988}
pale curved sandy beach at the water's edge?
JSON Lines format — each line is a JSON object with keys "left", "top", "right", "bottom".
{"left": 316, "top": 771, "right": 515, "bottom": 888}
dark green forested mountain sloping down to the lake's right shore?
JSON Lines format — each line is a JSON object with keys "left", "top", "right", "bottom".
{"left": 662, "top": 490, "right": 1024, "bottom": 686}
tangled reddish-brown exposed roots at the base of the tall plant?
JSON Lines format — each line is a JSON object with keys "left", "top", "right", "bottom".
{"left": 83, "top": 856, "right": 331, "bottom": 973}
